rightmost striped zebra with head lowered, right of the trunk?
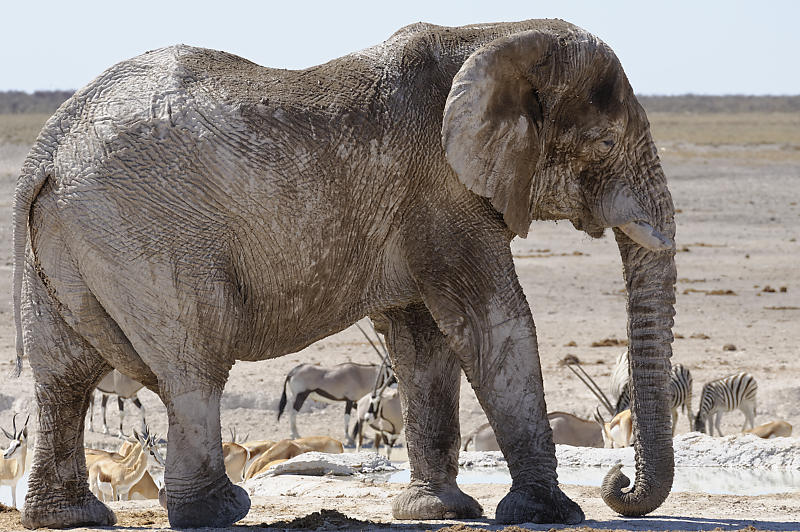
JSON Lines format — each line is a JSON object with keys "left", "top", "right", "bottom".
{"left": 694, "top": 372, "right": 758, "bottom": 436}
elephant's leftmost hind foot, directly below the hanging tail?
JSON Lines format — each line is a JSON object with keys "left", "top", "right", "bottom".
{"left": 20, "top": 494, "right": 117, "bottom": 528}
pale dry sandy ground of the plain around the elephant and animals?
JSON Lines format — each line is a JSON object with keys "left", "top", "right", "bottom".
{"left": 0, "top": 123, "right": 800, "bottom": 530}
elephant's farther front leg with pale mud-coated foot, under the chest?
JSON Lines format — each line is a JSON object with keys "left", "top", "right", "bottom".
{"left": 376, "top": 304, "right": 483, "bottom": 519}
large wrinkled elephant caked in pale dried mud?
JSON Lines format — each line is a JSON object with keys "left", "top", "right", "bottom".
{"left": 13, "top": 16, "right": 676, "bottom": 528}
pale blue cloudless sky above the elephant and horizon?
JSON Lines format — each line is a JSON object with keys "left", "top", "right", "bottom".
{"left": 0, "top": 0, "right": 800, "bottom": 95}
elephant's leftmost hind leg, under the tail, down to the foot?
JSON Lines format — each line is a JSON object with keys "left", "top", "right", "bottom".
{"left": 21, "top": 258, "right": 116, "bottom": 528}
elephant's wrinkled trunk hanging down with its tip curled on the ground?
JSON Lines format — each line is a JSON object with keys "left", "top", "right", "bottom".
{"left": 601, "top": 167, "right": 676, "bottom": 516}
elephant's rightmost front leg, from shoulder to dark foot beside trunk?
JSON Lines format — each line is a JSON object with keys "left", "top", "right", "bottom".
{"left": 409, "top": 222, "right": 584, "bottom": 523}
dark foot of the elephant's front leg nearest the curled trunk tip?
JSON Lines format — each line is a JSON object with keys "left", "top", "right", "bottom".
{"left": 495, "top": 486, "right": 585, "bottom": 525}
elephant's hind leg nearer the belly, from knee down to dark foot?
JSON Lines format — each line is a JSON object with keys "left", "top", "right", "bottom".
{"left": 161, "top": 376, "right": 250, "bottom": 528}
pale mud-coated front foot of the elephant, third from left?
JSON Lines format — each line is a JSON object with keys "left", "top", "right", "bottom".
{"left": 392, "top": 481, "right": 483, "bottom": 520}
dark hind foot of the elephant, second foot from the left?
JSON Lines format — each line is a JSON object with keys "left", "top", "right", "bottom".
{"left": 170, "top": 477, "right": 250, "bottom": 528}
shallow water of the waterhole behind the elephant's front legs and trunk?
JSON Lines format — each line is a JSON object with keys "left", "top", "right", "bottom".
{"left": 387, "top": 467, "right": 800, "bottom": 495}
